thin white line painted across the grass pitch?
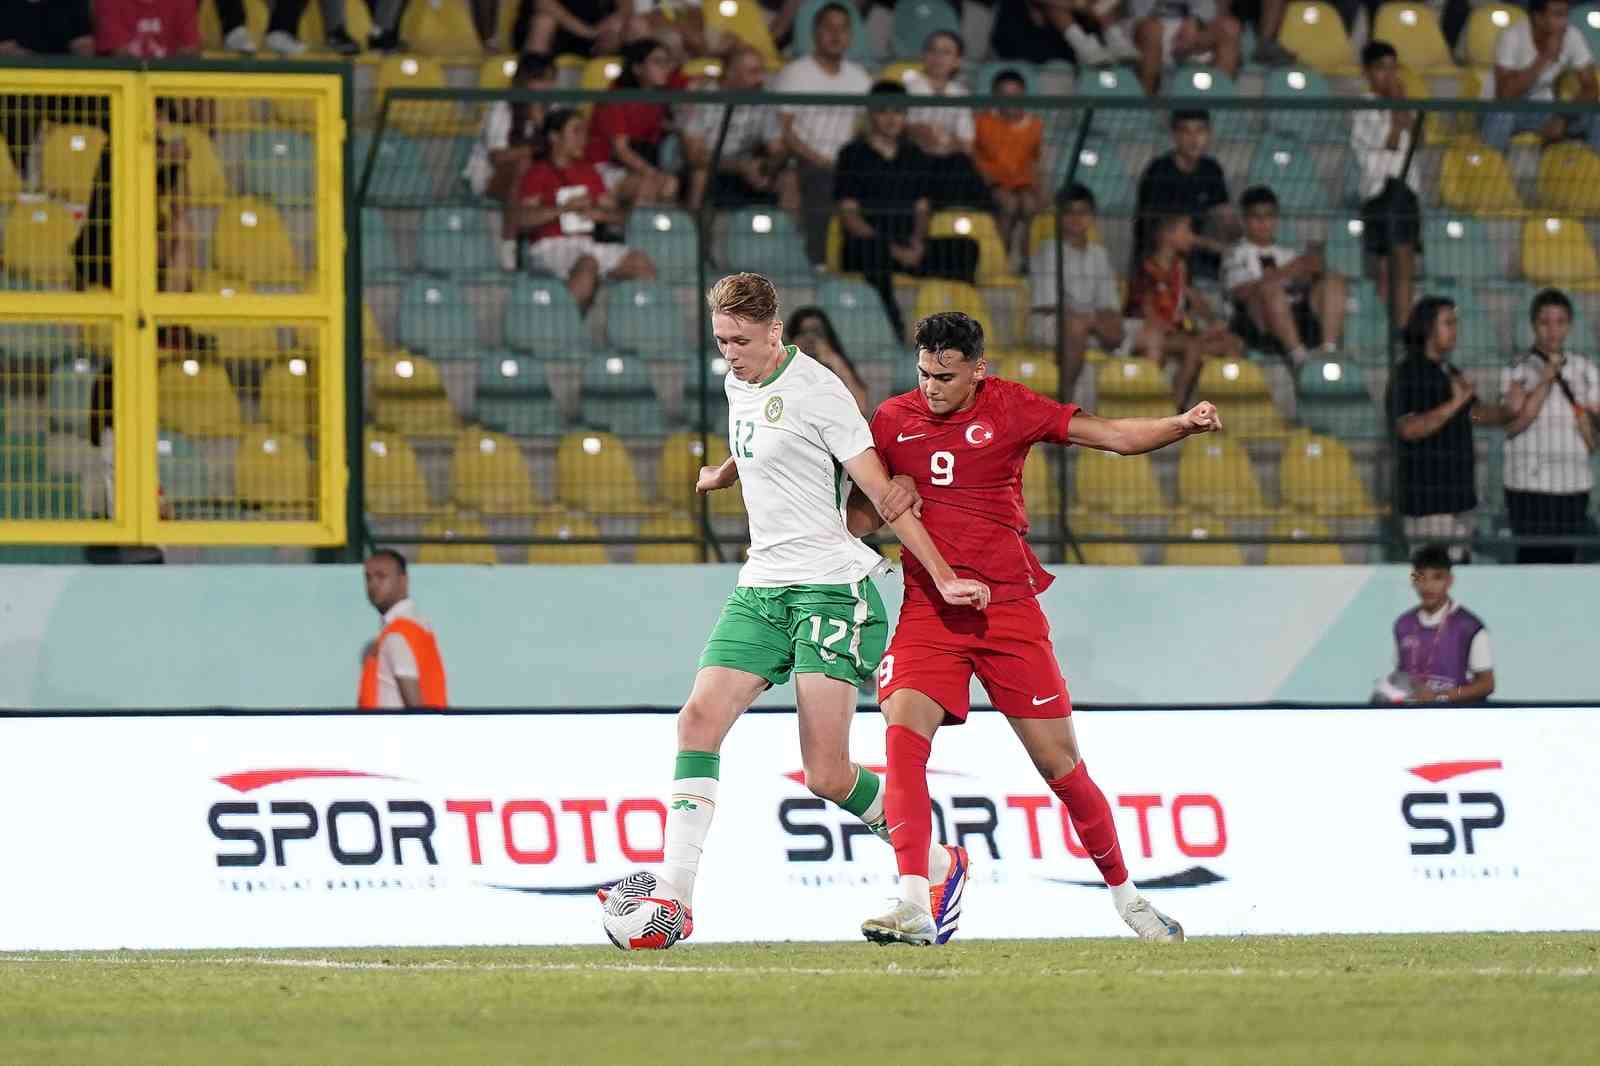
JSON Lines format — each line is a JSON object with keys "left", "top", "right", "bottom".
{"left": 0, "top": 954, "right": 1600, "bottom": 980}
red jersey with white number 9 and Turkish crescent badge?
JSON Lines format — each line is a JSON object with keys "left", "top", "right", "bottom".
{"left": 872, "top": 378, "right": 1078, "bottom": 605}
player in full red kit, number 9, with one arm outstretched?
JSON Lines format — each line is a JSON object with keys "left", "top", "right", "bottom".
{"left": 848, "top": 312, "right": 1222, "bottom": 944}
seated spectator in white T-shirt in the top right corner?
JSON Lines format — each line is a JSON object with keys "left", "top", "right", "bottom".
{"left": 1483, "top": 0, "right": 1600, "bottom": 152}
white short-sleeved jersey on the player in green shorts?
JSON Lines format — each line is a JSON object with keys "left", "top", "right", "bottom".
{"left": 723, "top": 346, "right": 883, "bottom": 589}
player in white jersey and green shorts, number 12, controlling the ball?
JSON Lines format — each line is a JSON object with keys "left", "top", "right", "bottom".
{"left": 600, "top": 274, "right": 989, "bottom": 948}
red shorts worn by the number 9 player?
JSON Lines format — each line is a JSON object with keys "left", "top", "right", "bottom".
{"left": 878, "top": 597, "right": 1072, "bottom": 725}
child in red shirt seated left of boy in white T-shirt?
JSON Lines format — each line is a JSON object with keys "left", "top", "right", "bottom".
{"left": 1128, "top": 214, "right": 1245, "bottom": 411}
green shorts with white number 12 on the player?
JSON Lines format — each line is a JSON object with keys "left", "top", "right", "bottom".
{"left": 699, "top": 578, "right": 890, "bottom": 688}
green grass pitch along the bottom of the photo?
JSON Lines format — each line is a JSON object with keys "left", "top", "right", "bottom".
{"left": 0, "top": 933, "right": 1600, "bottom": 1066}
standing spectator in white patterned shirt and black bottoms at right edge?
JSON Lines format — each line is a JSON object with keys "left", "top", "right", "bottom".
{"left": 1501, "top": 281, "right": 1600, "bottom": 563}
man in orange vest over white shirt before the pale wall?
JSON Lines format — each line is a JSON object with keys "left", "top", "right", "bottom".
{"left": 355, "top": 549, "right": 450, "bottom": 711}
